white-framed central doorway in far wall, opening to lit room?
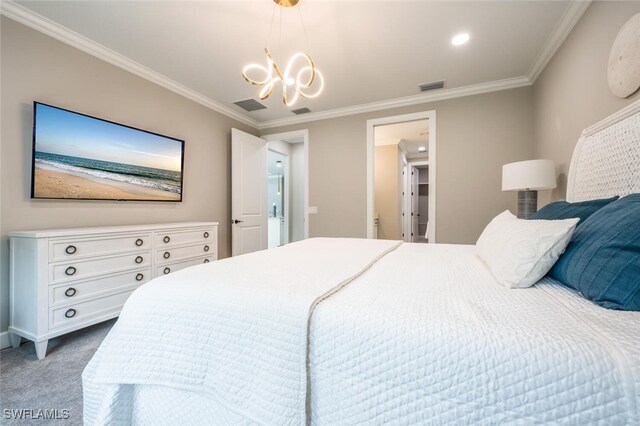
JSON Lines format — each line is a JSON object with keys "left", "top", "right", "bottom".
{"left": 367, "top": 111, "right": 436, "bottom": 242}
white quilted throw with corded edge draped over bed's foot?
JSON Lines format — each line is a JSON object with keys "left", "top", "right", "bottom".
{"left": 83, "top": 238, "right": 399, "bottom": 425}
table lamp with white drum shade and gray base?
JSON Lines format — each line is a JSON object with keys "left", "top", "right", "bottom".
{"left": 502, "top": 160, "right": 556, "bottom": 219}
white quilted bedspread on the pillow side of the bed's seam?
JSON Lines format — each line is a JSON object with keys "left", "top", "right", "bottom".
{"left": 310, "top": 244, "right": 640, "bottom": 425}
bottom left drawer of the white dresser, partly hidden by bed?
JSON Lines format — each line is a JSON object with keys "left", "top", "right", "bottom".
{"left": 49, "top": 290, "right": 133, "bottom": 328}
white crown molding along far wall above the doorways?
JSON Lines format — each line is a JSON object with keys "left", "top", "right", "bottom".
{"left": 258, "top": 76, "right": 531, "bottom": 130}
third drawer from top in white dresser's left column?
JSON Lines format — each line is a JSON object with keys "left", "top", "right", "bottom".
{"left": 49, "top": 268, "right": 151, "bottom": 307}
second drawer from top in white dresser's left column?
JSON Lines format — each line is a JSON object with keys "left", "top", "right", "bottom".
{"left": 49, "top": 251, "right": 151, "bottom": 285}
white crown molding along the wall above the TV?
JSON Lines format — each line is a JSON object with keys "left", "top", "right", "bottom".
{"left": 0, "top": 0, "right": 259, "bottom": 128}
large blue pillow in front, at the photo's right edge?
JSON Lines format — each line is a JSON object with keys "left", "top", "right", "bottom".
{"left": 549, "top": 194, "right": 640, "bottom": 311}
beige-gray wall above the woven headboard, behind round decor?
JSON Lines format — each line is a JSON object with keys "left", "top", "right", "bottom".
{"left": 534, "top": 1, "right": 640, "bottom": 205}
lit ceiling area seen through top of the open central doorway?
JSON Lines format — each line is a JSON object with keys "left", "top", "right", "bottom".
{"left": 374, "top": 119, "right": 429, "bottom": 160}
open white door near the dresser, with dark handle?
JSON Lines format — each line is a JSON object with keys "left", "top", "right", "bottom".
{"left": 231, "top": 129, "right": 268, "bottom": 256}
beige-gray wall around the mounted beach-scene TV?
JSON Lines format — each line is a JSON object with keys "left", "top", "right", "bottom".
{"left": 0, "top": 17, "right": 256, "bottom": 331}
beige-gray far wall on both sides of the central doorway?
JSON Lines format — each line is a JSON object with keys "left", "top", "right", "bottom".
{"left": 261, "top": 87, "right": 533, "bottom": 244}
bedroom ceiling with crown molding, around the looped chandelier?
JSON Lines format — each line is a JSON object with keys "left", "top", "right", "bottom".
{"left": 2, "top": 0, "right": 588, "bottom": 128}
